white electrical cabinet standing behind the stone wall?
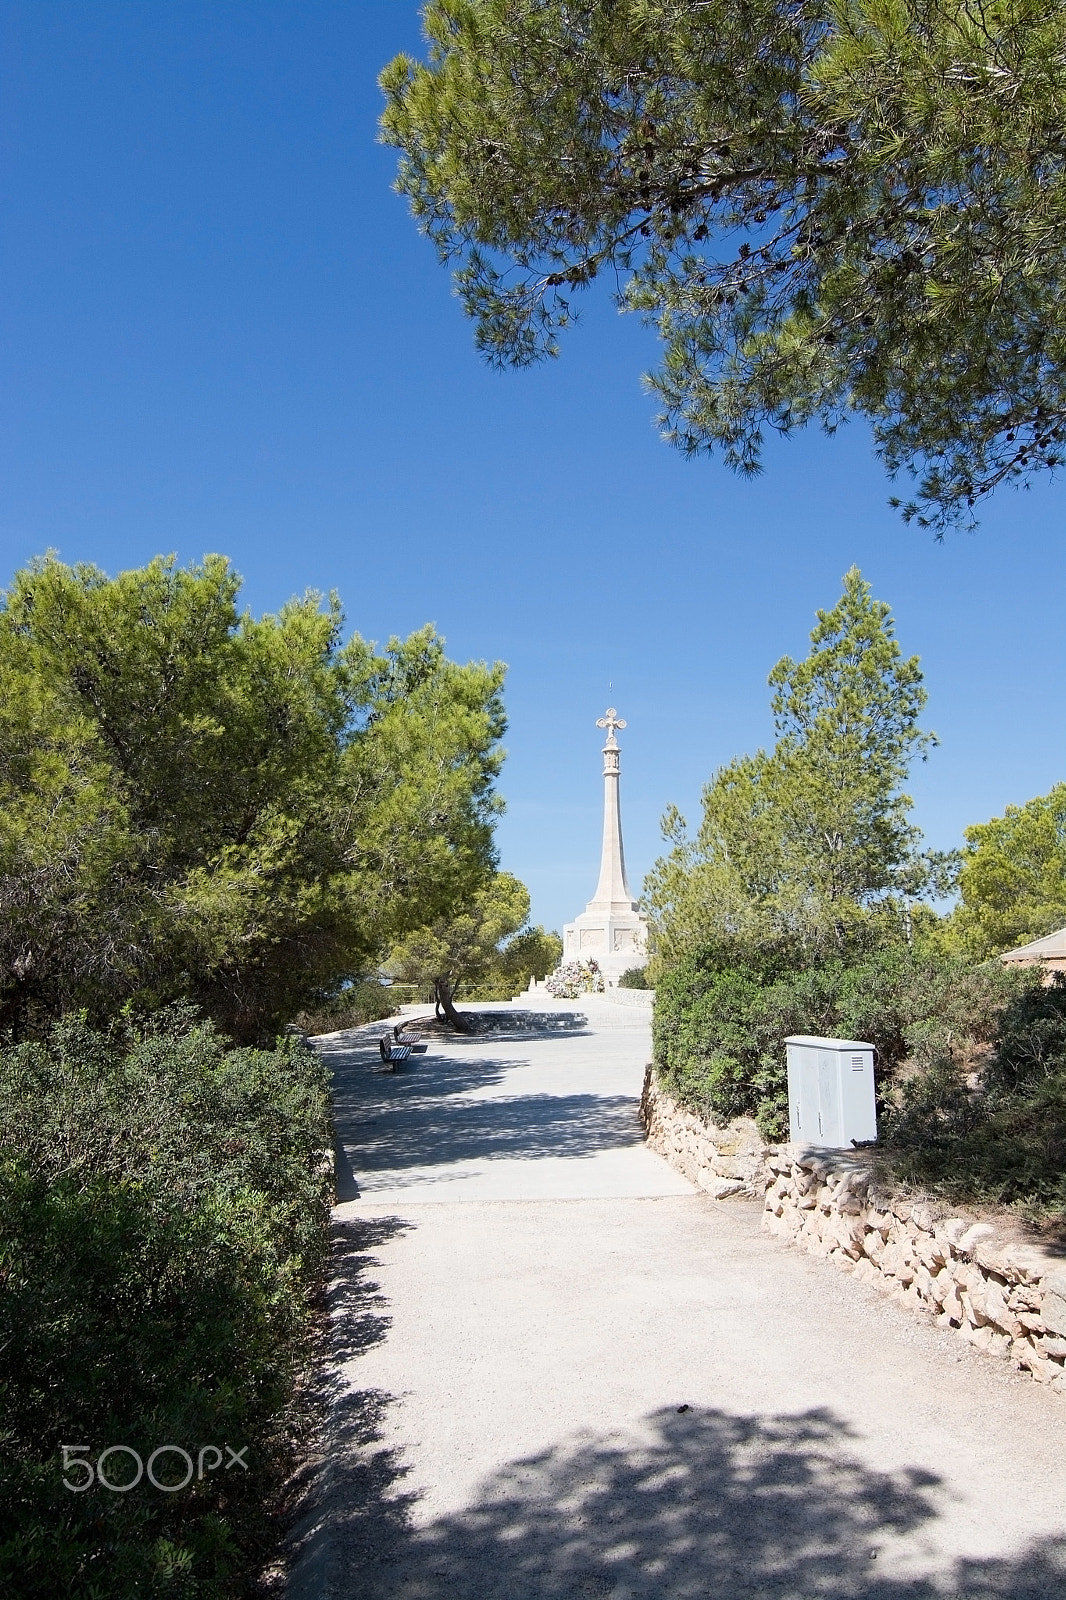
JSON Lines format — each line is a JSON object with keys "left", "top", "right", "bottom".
{"left": 784, "top": 1034, "right": 877, "bottom": 1150}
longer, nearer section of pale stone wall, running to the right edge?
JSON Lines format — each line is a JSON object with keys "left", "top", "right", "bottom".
{"left": 763, "top": 1146, "right": 1066, "bottom": 1395}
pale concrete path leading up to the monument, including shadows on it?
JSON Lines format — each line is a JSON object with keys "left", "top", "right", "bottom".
{"left": 290, "top": 1002, "right": 1066, "bottom": 1600}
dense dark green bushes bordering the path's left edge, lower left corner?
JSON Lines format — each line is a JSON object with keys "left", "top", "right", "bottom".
{"left": 0, "top": 1008, "right": 330, "bottom": 1600}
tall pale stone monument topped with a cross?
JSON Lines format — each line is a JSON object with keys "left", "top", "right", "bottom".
{"left": 563, "top": 706, "right": 647, "bottom": 986}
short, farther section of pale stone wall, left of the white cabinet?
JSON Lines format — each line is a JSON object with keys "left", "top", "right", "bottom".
{"left": 632, "top": 1068, "right": 770, "bottom": 1200}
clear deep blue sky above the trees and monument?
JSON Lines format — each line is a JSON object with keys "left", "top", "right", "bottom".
{"left": 0, "top": 0, "right": 1066, "bottom": 926}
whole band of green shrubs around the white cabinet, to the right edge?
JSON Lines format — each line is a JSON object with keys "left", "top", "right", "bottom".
{"left": 655, "top": 946, "right": 1066, "bottom": 1218}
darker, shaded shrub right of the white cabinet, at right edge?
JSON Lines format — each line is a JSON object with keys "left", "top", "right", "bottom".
{"left": 887, "top": 973, "right": 1066, "bottom": 1221}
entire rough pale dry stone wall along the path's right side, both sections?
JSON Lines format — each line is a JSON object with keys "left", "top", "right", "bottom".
{"left": 640, "top": 1067, "right": 1066, "bottom": 1397}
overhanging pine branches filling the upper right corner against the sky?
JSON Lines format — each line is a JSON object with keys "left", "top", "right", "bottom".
{"left": 381, "top": 0, "right": 1066, "bottom": 533}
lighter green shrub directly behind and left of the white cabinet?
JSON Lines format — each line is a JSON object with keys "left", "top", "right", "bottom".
{"left": 653, "top": 944, "right": 1029, "bottom": 1139}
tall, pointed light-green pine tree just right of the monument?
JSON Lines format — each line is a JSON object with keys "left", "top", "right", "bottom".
{"left": 645, "top": 568, "right": 943, "bottom": 974}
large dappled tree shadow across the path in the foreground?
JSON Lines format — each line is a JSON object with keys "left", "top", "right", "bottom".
{"left": 330, "top": 1408, "right": 1066, "bottom": 1600}
